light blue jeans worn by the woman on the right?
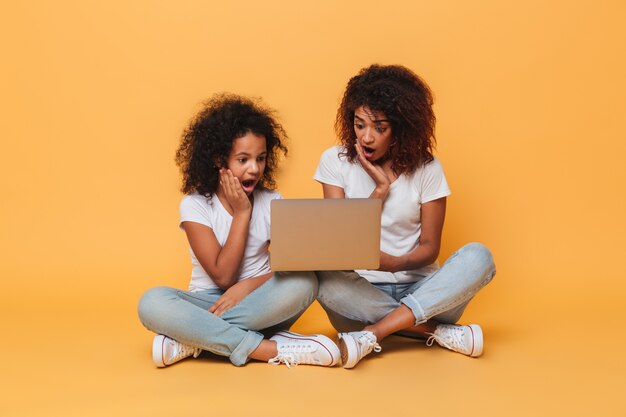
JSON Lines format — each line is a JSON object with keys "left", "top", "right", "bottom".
{"left": 316, "top": 243, "right": 496, "bottom": 331}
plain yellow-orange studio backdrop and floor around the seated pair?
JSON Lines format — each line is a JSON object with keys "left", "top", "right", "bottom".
{"left": 0, "top": 0, "right": 626, "bottom": 416}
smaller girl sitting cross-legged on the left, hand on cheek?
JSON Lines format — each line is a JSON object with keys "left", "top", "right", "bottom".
{"left": 139, "top": 95, "right": 339, "bottom": 367}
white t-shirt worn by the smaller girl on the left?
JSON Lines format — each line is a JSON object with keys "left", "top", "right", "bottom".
{"left": 180, "top": 190, "right": 282, "bottom": 292}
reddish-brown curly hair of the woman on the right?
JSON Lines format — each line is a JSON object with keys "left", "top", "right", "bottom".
{"left": 335, "top": 64, "right": 436, "bottom": 175}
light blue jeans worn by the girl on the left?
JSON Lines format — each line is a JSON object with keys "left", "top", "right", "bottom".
{"left": 138, "top": 272, "right": 317, "bottom": 366}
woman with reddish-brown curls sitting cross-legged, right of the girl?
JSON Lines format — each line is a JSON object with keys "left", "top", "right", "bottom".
{"left": 314, "top": 65, "right": 495, "bottom": 368}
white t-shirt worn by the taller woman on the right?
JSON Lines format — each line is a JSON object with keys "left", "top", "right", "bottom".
{"left": 313, "top": 146, "right": 450, "bottom": 283}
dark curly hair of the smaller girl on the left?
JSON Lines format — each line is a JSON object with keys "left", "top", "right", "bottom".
{"left": 176, "top": 93, "right": 287, "bottom": 198}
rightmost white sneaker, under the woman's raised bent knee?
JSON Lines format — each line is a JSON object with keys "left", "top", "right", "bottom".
{"left": 426, "top": 324, "right": 483, "bottom": 358}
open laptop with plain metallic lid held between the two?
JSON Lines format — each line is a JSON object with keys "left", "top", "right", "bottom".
{"left": 270, "top": 198, "right": 382, "bottom": 271}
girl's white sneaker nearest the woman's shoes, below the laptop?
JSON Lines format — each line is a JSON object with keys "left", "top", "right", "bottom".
{"left": 267, "top": 331, "right": 339, "bottom": 368}
